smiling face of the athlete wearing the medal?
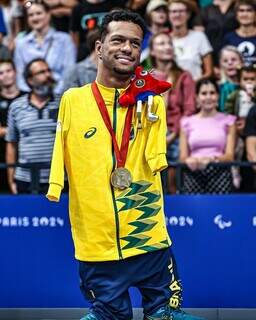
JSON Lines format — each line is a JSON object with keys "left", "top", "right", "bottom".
{"left": 96, "top": 21, "right": 143, "bottom": 76}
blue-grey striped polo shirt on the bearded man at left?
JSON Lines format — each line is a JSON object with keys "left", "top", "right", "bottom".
{"left": 5, "top": 94, "right": 59, "bottom": 183}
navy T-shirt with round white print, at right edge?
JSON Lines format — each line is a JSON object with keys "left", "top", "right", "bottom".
{"left": 223, "top": 31, "right": 256, "bottom": 64}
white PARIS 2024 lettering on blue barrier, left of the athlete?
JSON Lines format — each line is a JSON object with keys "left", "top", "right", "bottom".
{"left": 0, "top": 216, "right": 64, "bottom": 228}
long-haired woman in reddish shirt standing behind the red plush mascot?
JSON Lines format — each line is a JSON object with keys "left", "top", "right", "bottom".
{"left": 150, "top": 32, "right": 196, "bottom": 193}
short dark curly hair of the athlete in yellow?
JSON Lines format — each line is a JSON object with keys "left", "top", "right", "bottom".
{"left": 100, "top": 9, "right": 147, "bottom": 41}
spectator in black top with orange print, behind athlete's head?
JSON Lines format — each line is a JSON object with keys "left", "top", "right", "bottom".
{"left": 70, "top": 0, "right": 125, "bottom": 61}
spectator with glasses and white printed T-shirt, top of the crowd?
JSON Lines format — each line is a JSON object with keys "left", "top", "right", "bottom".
{"left": 169, "top": 0, "right": 213, "bottom": 80}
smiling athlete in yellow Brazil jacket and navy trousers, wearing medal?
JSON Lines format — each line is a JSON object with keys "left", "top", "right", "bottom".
{"left": 47, "top": 11, "right": 204, "bottom": 320}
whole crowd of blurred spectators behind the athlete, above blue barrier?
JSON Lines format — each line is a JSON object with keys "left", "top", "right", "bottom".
{"left": 0, "top": 0, "right": 256, "bottom": 194}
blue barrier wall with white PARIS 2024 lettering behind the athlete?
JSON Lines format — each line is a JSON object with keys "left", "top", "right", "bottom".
{"left": 0, "top": 195, "right": 256, "bottom": 308}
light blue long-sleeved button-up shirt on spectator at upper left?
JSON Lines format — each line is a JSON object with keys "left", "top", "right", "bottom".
{"left": 14, "top": 29, "right": 76, "bottom": 94}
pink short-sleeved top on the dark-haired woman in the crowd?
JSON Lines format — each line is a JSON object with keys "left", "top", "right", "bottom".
{"left": 181, "top": 112, "right": 236, "bottom": 157}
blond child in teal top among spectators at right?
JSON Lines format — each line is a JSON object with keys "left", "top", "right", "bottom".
{"left": 219, "top": 46, "right": 243, "bottom": 112}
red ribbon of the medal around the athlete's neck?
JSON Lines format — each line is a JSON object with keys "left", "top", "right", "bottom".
{"left": 92, "top": 81, "right": 133, "bottom": 168}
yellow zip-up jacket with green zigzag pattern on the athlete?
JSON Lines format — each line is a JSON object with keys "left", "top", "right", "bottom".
{"left": 47, "top": 84, "right": 171, "bottom": 261}
